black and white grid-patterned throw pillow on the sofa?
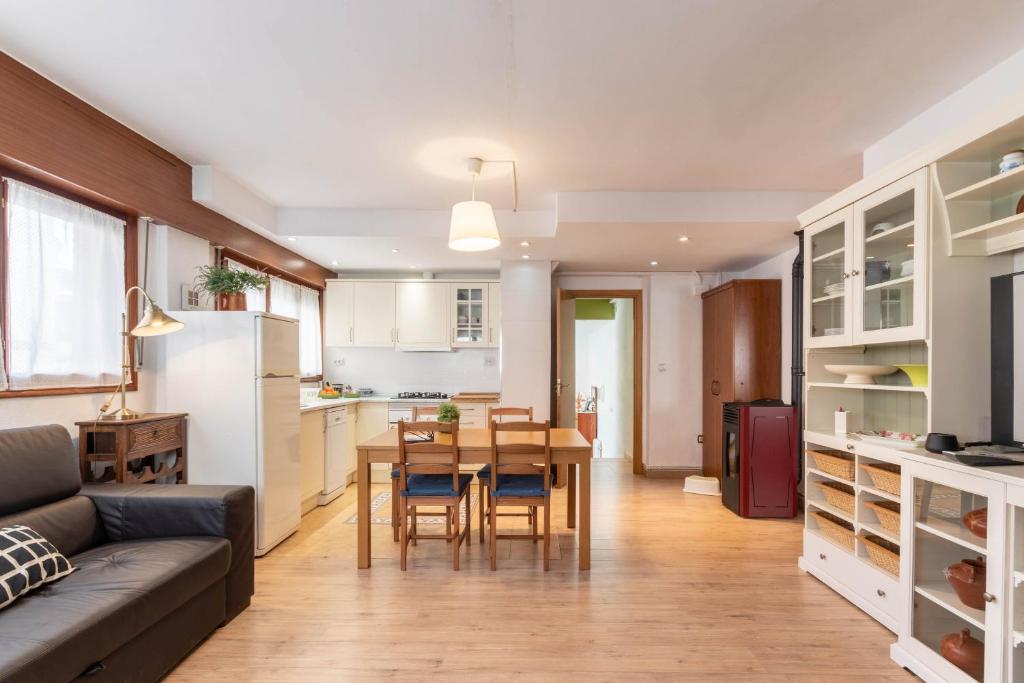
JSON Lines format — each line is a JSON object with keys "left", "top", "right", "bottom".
{"left": 0, "top": 525, "right": 75, "bottom": 609}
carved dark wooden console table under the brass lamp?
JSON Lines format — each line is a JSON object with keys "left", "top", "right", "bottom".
{"left": 75, "top": 413, "right": 188, "bottom": 483}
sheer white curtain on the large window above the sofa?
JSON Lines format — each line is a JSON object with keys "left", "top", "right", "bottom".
{"left": 6, "top": 180, "right": 125, "bottom": 389}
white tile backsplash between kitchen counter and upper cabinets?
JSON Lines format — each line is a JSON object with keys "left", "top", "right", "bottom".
{"left": 324, "top": 347, "right": 501, "bottom": 393}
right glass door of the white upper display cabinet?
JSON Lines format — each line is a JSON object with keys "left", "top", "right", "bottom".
{"left": 850, "top": 169, "right": 928, "bottom": 344}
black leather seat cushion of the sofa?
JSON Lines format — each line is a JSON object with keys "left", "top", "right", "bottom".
{"left": 0, "top": 537, "right": 230, "bottom": 681}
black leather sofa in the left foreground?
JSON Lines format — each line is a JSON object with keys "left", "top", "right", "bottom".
{"left": 0, "top": 425, "right": 255, "bottom": 682}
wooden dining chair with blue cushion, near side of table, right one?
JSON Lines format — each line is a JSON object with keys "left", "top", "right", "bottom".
{"left": 487, "top": 420, "right": 553, "bottom": 571}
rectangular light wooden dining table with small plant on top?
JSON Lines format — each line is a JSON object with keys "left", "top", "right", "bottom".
{"left": 355, "top": 428, "right": 594, "bottom": 570}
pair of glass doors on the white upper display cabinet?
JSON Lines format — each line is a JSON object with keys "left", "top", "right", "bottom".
{"left": 804, "top": 168, "right": 929, "bottom": 348}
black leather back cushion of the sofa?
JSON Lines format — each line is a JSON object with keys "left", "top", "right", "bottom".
{"left": 0, "top": 425, "right": 82, "bottom": 515}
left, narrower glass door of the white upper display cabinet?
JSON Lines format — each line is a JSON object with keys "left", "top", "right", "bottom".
{"left": 804, "top": 207, "right": 853, "bottom": 348}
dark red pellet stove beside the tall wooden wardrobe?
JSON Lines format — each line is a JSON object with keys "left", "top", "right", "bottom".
{"left": 722, "top": 400, "right": 800, "bottom": 517}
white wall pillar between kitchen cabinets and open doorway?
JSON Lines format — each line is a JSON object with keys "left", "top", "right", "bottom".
{"left": 501, "top": 260, "right": 551, "bottom": 420}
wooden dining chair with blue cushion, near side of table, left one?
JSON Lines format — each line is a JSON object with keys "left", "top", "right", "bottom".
{"left": 398, "top": 420, "right": 473, "bottom": 571}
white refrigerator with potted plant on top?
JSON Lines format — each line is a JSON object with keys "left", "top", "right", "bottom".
{"left": 156, "top": 311, "right": 302, "bottom": 555}
